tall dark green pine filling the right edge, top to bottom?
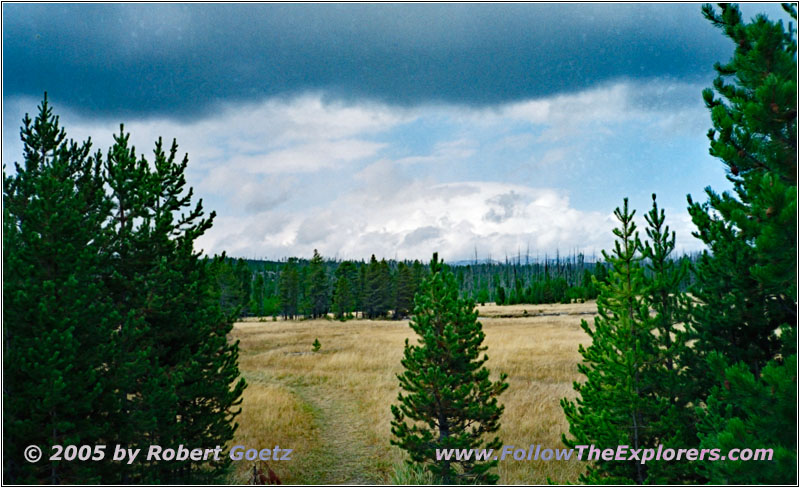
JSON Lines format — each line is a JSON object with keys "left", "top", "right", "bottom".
{"left": 687, "top": 4, "right": 797, "bottom": 484}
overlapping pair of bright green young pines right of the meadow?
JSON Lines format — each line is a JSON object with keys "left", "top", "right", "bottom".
{"left": 561, "top": 199, "right": 685, "bottom": 484}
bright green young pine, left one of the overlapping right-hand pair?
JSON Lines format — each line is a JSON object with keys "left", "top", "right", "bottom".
{"left": 561, "top": 198, "right": 668, "bottom": 484}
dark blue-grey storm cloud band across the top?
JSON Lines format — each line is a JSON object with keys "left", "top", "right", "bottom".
{"left": 3, "top": 4, "right": 780, "bottom": 117}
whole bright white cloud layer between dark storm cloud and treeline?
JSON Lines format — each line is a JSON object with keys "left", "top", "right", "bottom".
{"left": 3, "top": 82, "right": 707, "bottom": 260}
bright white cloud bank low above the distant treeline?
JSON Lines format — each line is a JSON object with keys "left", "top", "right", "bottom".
{"left": 195, "top": 168, "right": 612, "bottom": 259}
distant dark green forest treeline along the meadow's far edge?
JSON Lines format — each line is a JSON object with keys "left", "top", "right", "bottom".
{"left": 213, "top": 250, "right": 696, "bottom": 319}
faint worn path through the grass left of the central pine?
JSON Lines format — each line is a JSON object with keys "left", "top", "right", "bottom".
{"left": 293, "top": 385, "right": 386, "bottom": 485}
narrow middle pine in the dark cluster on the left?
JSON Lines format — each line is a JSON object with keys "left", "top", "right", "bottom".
{"left": 101, "top": 127, "right": 171, "bottom": 484}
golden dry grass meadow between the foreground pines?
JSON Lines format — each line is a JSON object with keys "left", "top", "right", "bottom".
{"left": 225, "top": 303, "right": 595, "bottom": 484}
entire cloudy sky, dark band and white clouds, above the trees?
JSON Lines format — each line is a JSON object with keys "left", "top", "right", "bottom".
{"left": 2, "top": 3, "right": 785, "bottom": 260}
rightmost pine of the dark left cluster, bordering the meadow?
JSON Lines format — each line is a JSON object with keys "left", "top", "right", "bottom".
{"left": 145, "top": 135, "right": 245, "bottom": 483}
